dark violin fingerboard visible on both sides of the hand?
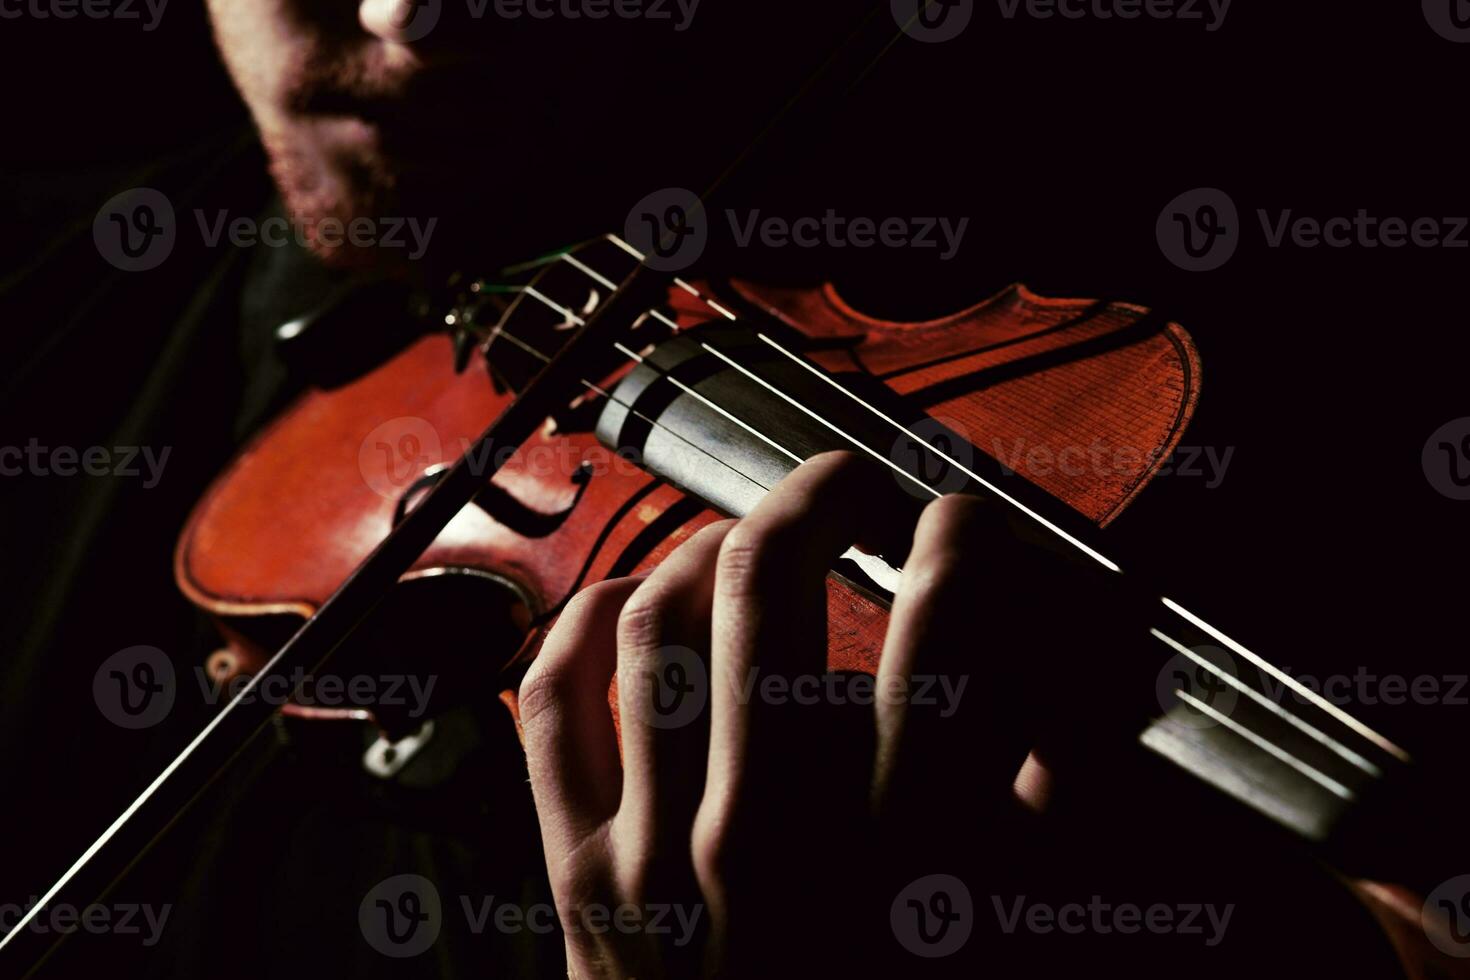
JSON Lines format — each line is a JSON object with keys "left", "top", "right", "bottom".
{"left": 585, "top": 307, "right": 1435, "bottom": 887}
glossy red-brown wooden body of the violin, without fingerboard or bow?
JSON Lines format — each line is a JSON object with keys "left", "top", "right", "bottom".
{"left": 175, "top": 260, "right": 1200, "bottom": 735}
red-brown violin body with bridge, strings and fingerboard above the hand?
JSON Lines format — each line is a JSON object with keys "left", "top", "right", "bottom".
{"left": 175, "top": 237, "right": 1200, "bottom": 743}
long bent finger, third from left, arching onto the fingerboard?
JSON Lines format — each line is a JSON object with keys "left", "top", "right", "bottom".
{"left": 691, "top": 453, "right": 903, "bottom": 975}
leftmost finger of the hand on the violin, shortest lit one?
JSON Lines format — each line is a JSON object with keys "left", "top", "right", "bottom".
{"left": 520, "top": 579, "right": 641, "bottom": 886}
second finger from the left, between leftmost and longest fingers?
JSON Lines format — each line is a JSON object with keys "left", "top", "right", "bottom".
{"left": 616, "top": 522, "right": 735, "bottom": 867}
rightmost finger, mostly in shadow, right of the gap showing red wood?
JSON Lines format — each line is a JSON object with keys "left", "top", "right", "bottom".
{"left": 873, "top": 494, "right": 1032, "bottom": 826}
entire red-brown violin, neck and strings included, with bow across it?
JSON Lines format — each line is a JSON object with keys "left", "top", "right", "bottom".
{"left": 12, "top": 227, "right": 1458, "bottom": 963}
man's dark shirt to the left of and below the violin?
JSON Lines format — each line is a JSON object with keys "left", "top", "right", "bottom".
{"left": 0, "top": 135, "right": 560, "bottom": 977}
